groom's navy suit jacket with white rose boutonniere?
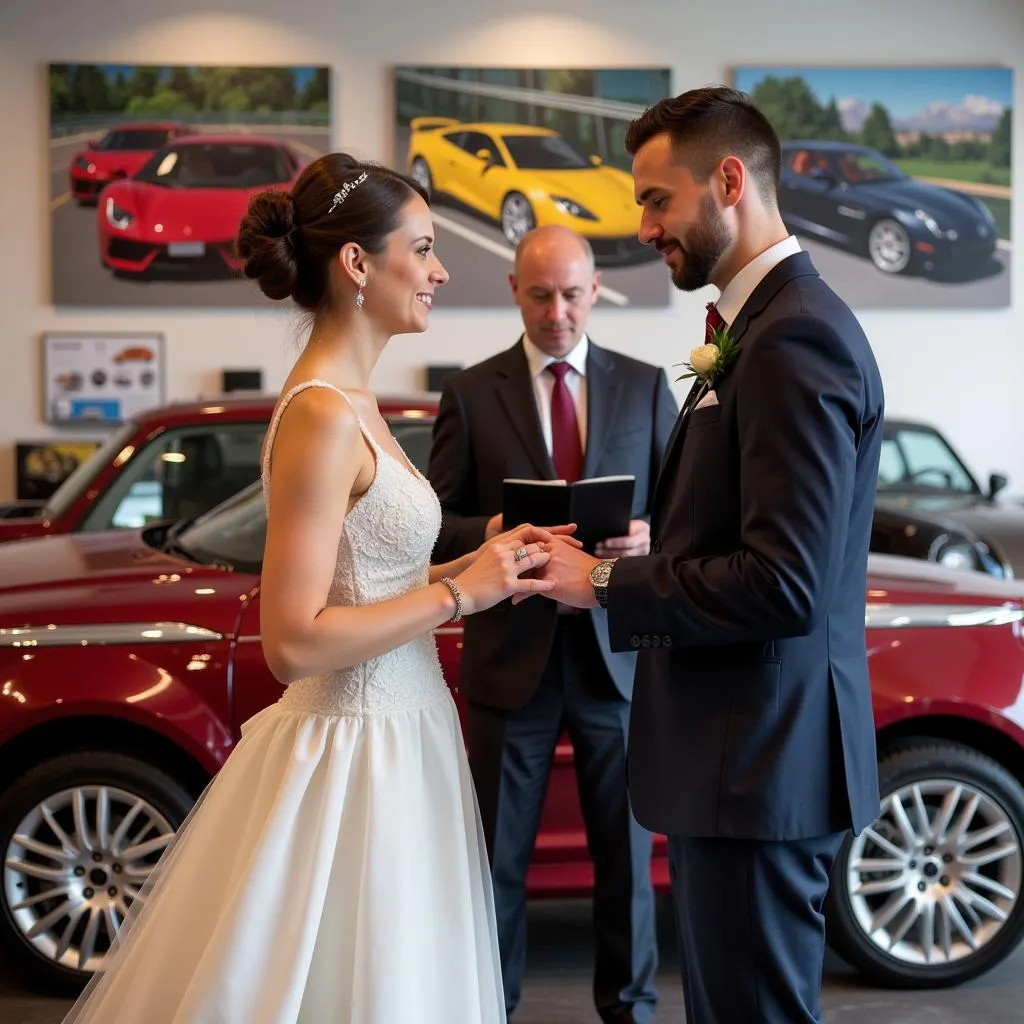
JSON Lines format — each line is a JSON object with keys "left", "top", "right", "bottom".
{"left": 608, "top": 253, "right": 883, "bottom": 841}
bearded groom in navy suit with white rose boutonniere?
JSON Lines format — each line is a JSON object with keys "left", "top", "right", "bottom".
{"left": 543, "top": 88, "right": 883, "bottom": 1024}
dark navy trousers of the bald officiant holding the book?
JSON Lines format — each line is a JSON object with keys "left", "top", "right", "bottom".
{"left": 466, "top": 614, "right": 657, "bottom": 1024}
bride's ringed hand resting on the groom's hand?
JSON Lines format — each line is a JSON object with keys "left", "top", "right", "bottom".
{"left": 455, "top": 526, "right": 574, "bottom": 615}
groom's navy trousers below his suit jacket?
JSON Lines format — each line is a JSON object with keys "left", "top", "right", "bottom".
{"left": 669, "top": 833, "right": 846, "bottom": 1024}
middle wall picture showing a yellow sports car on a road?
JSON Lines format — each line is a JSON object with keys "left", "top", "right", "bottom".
{"left": 393, "top": 66, "right": 672, "bottom": 308}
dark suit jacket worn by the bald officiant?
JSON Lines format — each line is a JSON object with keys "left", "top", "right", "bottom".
{"left": 428, "top": 339, "right": 678, "bottom": 711}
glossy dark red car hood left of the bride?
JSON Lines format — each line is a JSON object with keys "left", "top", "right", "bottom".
{"left": 0, "top": 530, "right": 258, "bottom": 635}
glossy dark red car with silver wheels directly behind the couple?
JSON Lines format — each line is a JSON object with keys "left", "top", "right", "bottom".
{"left": 0, "top": 471, "right": 1024, "bottom": 991}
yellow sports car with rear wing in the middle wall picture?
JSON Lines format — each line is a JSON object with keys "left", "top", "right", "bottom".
{"left": 407, "top": 117, "right": 656, "bottom": 264}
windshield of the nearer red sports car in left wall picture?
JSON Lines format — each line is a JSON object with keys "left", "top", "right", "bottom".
{"left": 135, "top": 142, "right": 291, "bottom": 188}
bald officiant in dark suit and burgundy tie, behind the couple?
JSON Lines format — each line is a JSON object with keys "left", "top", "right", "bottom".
{"left": 428, "top": 226, "right": 678, "bottom": 1024}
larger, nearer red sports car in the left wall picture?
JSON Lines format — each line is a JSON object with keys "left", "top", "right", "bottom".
{"left": 97, "top": 135, "right": 306, "bottom": 274}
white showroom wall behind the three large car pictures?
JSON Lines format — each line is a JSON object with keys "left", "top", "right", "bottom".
{"left": 0, "top": 0, "right": 1024, "bottom": 500}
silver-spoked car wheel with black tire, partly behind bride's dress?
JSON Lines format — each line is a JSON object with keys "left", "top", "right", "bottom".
{"left": 0, "top": 751, "right": 194, "bottom": 995}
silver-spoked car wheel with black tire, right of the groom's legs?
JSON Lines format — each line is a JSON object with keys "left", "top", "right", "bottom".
{"left": 825, "top": 739, "right": 1024, "bottom": 988}
